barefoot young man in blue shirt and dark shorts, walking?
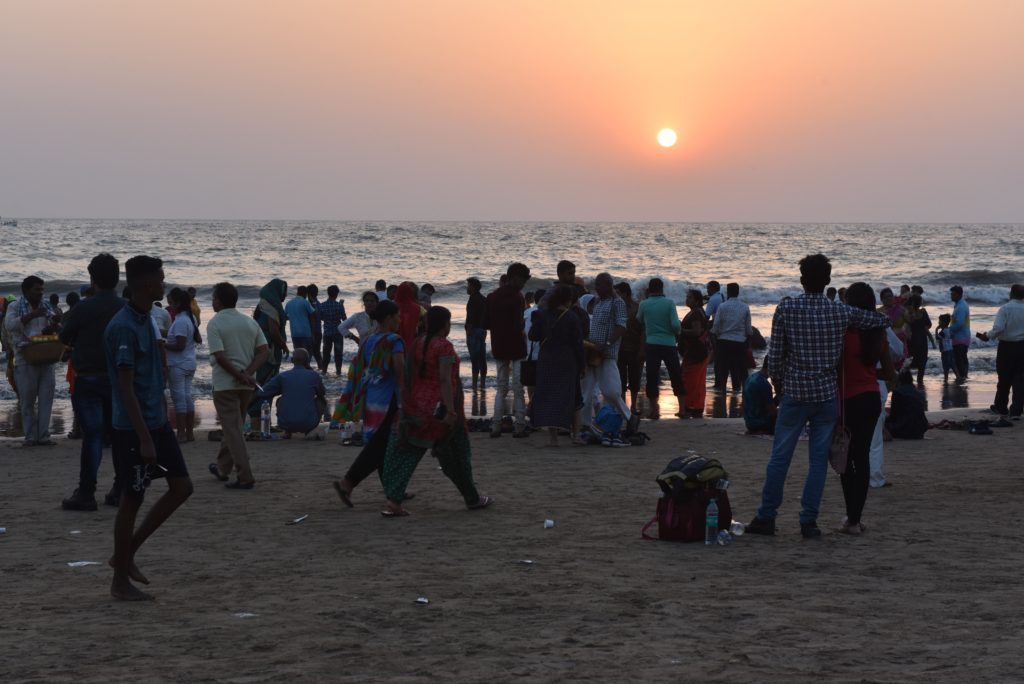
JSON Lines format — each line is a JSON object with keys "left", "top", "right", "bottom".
{"left": 103, "top": 256, "right": 193, "bottom": 601}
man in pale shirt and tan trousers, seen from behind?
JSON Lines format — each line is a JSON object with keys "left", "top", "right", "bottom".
{"left": 206, "top": 283, "right": 268, "bottom": 489}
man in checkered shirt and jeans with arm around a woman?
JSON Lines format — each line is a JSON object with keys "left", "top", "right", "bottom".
{"left": 746, "top": 254, "right": 890, "bottom": 538}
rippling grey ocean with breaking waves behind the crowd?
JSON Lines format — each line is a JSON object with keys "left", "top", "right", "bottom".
{"left": 0, "top": 218, "right": 1024, "bottom": 434}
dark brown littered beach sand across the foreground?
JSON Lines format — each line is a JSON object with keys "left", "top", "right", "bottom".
{"left": 0, "top": 411, "right": 1024, "bottom": 682}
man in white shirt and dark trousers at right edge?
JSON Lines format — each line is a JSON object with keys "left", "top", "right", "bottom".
{"left": 978, "top": 285, "right": 1024, "bottom": 418}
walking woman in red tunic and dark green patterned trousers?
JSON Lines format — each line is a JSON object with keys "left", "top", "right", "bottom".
{"left": 381, "top": 306, "right": 494, "bottom": 517}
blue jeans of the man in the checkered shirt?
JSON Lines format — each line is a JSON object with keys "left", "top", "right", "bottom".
{"left": 758, "top": 394, "right": 837, "bottom": 523}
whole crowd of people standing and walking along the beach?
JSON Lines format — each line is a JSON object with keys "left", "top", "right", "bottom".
{"left": 2, "top": 254, "right": 1024, "bottom": 600}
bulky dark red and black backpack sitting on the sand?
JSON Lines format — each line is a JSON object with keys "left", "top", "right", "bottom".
{"left": 640, "top": 456, "right": 732, "bottom": 542}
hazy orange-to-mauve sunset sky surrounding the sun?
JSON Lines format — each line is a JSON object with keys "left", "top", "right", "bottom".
{"left": 0, "top": 0, "right": 1024, "bottom": 222}
